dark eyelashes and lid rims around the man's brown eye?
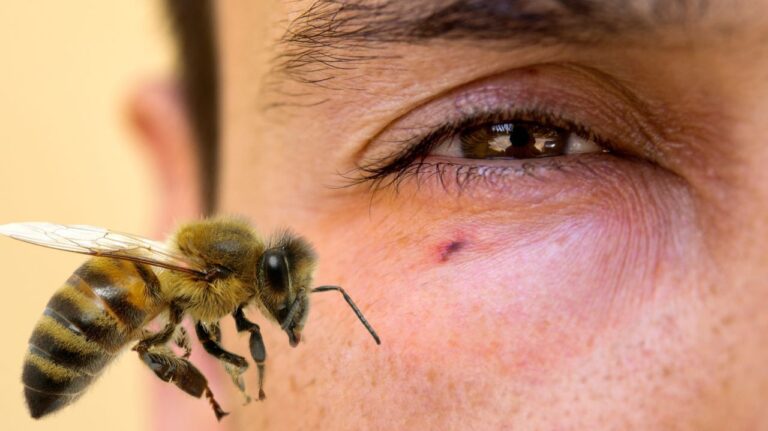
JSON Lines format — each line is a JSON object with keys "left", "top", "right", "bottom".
{"left": 347, "top": 110, "right": 615, "bottom": 191}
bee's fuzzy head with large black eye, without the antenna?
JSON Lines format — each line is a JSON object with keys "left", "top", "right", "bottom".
{"left": 257, "top": 233, "right": 316, "bottom": 347}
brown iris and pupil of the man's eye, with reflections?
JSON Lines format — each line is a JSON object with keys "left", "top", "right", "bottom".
{"left": 459, "top": 122, "right": 569, "bottom": 159}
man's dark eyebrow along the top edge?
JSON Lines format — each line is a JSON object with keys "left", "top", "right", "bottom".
{"left": 272, "top": 0, "right": 709, "bottom": 86}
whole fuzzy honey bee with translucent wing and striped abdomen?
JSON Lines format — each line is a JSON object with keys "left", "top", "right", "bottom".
{"left": 0, "top": 217, "right": 381, "bottom": 420}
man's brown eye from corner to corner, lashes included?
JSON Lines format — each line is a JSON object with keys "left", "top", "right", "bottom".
{"left": 353, "top": 111, "right": 621, "bottom": 200}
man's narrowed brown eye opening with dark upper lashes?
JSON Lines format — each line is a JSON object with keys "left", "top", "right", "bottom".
{"left": 358, "top": 112, "right": 610, "bottom": 192}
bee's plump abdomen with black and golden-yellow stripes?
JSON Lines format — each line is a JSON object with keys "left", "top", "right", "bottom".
{"left": 22, "top": 257, "right": 162, "bottom": 418}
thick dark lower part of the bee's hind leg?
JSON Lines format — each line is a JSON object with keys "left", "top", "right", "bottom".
{"left": 139, "top": 346, "right": 229, "bottom": 420}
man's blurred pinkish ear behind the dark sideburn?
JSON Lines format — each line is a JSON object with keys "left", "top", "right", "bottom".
{"left": 128, "top": 80, "right": 202, "bottom": 234}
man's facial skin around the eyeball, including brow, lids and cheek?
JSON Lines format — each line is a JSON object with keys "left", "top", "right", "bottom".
{"left": 134, "top": 0, "right": 768, "bottom": 430}
